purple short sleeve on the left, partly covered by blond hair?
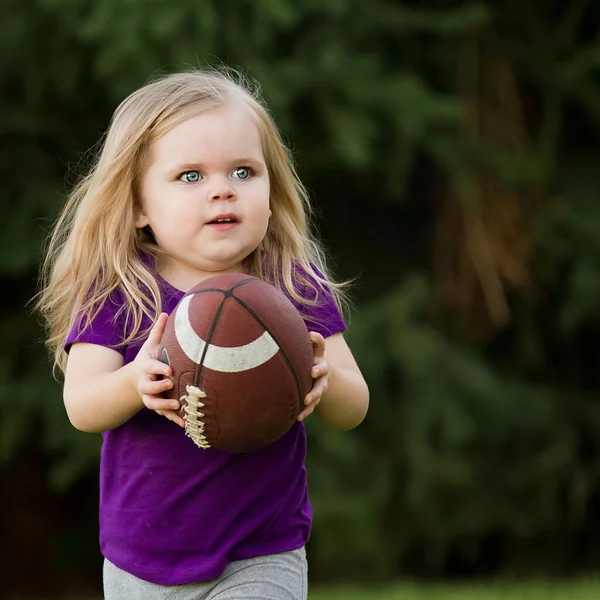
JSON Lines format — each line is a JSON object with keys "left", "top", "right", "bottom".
{"left": 64, "top": 292, "right": 125, "bottom": 356}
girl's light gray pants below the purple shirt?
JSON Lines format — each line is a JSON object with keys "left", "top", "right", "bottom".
{"left": 104, "top": 548, "right": 308, "bottom": 600}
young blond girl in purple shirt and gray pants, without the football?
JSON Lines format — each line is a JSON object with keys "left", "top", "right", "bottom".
{"left": 39, "top": 72, "right": 368, "bottom": 600}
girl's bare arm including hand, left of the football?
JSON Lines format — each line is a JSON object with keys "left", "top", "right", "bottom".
{"left": 63, "top": 313, "right": 185, "bottom": 433}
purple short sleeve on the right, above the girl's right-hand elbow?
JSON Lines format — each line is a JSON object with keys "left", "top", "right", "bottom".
{"left": 298, "top": 271, "right": 346, "bottom": 337}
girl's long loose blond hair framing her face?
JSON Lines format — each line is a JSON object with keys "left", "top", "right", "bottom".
{"left": 37, "top": 70, "right": 347, "bottom": 372}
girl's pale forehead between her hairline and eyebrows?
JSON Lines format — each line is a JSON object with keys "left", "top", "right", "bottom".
{"left": 150, "top": 104, "right": 263, "bottom": 163}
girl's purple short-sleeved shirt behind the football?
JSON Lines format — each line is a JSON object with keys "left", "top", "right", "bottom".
{"left": 65, "top": 278, "right": 345, "bottom": 585}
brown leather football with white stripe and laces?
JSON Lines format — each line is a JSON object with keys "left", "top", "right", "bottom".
{"left": 161, "top": 273, "right": 313, "bottom": 452}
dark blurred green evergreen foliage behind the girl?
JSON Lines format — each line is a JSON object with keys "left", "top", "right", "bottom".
{"left": 0, "top": 0, "right": 600, "bottom": 592}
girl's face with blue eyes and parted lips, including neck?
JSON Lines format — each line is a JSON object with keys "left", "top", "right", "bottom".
{"left": 135, "top": 104, "right": 271, "bottom": 291}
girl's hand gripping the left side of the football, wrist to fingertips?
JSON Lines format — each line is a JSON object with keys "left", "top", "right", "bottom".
{"left": 133, "top": 313, "right": 185, "bottom": 427}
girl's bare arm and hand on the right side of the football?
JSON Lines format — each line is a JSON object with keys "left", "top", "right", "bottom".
{"left": 299, "top": 333, "right": 369, "bottom": 430}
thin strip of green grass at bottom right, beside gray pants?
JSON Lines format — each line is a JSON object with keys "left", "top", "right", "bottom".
{"left": 308, "top": 579, "right": 600, "bottom": 600}
